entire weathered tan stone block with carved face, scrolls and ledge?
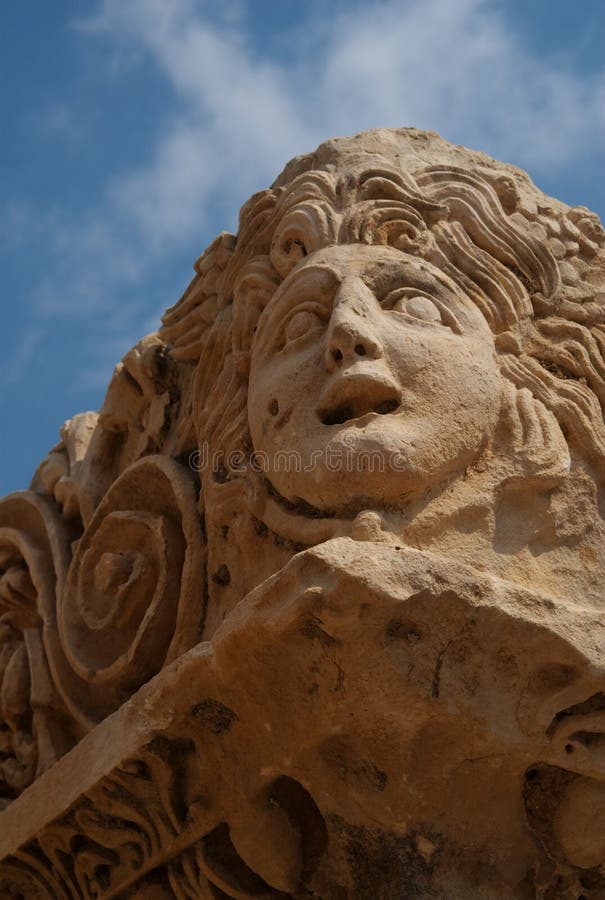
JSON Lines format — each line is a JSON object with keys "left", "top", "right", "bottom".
{"left": 0, "top": 129, "right": 605, "bottom": 900}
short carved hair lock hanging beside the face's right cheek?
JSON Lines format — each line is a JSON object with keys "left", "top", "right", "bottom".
{"left": 496, "top": 383, "right": 571, "bottom": 484}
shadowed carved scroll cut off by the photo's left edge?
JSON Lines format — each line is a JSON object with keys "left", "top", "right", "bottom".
{"left": 0, "top": 491, "right": 73, "bottom": 804}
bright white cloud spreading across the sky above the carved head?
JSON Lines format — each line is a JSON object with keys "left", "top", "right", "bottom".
{"left": 80, "top": 0, "right": 603, "bottom": 256}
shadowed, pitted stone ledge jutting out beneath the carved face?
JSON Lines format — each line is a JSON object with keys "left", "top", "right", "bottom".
{"left": 0, "top": 538, "right": 605, "bottom": 900}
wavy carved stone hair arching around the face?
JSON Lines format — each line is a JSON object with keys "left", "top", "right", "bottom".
{"left": 161, "top": 135, "right": 605, "bottom": 486}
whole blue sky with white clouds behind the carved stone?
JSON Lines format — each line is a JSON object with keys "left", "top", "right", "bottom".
{"left": 0, "top": 0, "right": 605, "bottom": 495}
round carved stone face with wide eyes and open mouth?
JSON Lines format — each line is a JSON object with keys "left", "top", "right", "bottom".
{"left": 248, "top": 244, "right": 502, "bottom": 511}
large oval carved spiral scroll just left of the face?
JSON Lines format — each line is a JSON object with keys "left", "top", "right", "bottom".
{"left": 46, "top": 456, "right": 205, "bottom": 728}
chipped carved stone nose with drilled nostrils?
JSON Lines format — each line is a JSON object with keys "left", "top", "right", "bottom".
{"left": 326, "top": 278, "right": 382, "bottom": 370}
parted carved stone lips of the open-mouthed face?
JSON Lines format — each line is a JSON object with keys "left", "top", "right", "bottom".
{"left": 317, "top": 368, "right": 401, "bottom": 425}
